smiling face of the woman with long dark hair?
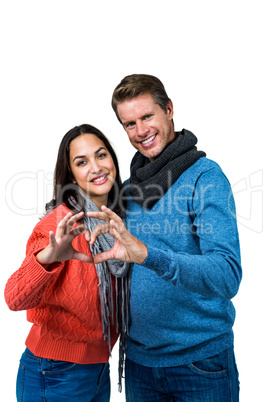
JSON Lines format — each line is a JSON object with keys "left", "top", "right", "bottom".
{"left": 69, "top": 134, "right": 116, "bottom": 209}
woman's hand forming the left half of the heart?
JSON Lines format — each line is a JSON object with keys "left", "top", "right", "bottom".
{"left": 36, "top": 212, "right": 93, "bottom": 267}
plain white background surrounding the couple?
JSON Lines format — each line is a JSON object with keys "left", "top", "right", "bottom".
{"left": 0, "top": 0, "right": 268, "bottom": 402}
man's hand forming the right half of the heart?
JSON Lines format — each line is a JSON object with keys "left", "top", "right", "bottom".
{"left": 87, "top": 205, "right": 148, "bottom": 264}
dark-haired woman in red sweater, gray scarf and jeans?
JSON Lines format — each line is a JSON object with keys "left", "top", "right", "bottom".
{"left": 5, "top": 124, "right": 128, "bottom": 402}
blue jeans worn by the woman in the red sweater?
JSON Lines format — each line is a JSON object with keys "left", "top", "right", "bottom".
{"left": 16, "top": 348, "right": 110, "bottom": 402}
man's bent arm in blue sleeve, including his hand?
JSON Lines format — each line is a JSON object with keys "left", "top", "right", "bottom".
{"left": 88, "top": 169, "right": 242, "bottom": 299}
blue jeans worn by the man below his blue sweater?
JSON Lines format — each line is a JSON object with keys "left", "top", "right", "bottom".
{"left": 125, "top": 348, "right": 239, "bottom": 402}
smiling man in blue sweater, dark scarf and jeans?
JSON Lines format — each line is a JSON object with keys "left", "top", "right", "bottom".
{"left": 90, "top": 74, "right": 242, "bottom": 402}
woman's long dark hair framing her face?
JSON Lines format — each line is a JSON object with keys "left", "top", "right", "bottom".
{"left": 46, "top": 124, "right": 122, "bottom": 213}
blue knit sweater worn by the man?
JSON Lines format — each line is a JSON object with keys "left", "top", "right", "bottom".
{"left": 124, "top": 158, "right": 242, "bottom": 367}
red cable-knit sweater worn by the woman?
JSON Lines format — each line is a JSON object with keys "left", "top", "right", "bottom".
{"left": 5, "top": 205, "right": 118, "bottom": 364}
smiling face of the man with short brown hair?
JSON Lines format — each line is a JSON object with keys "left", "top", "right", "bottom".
{"left": 117, "top": 94, "right": 175, "bottom": 162}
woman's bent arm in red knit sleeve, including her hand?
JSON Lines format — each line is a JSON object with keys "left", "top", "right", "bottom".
{"left": 5, "top": 213, "right": 93, "bottom": 311}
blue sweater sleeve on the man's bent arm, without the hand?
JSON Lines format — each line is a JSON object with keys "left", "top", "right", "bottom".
{"left": 142, "top": 169, "right": 242, "bottom": 299}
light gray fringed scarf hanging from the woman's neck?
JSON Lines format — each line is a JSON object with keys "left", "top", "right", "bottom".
{"left": 80, "top": 191, "right": 132, "bottom": 392}
